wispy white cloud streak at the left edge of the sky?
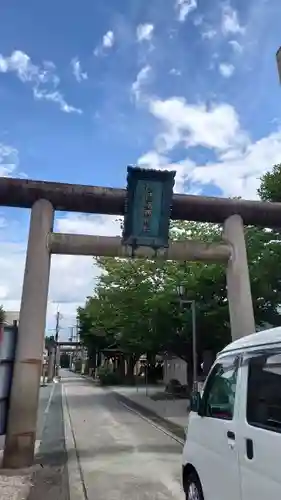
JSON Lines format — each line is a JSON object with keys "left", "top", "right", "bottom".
{"left": 0, "top": 50, "right": 82, "bottom": 113}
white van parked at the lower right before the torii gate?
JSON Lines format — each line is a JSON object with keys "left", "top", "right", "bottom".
{"left": 183, "top": 327, "right": 281, "bottom": 500}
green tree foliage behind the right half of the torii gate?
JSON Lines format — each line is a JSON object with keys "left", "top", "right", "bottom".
{"left": 78, "top": 218, "right": 281, "bottom": 368}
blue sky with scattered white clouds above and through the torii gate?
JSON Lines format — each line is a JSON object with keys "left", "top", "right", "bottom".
{"left": 0, "top": 0, "right": 281, "bottom": 338}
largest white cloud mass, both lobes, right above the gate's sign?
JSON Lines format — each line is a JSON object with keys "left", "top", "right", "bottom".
{"left": 138, "top": 92, "right": 281, "bottom": 199}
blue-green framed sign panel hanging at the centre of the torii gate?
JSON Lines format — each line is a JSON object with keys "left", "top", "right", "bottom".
{"left": 123, "top": 167, "right": 175, "bottom": 249}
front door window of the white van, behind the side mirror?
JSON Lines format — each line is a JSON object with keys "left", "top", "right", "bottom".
{"left": 203, "top": 356, "right": 239, "bottom": 420}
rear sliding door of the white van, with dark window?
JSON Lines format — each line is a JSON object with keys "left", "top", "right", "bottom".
{"left": 237, "top": 349, "right": 281, "bottom": 500}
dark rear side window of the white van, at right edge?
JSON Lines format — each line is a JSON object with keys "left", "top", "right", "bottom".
{"left": 247, "top": 352, "right": 281, "bottom": 432}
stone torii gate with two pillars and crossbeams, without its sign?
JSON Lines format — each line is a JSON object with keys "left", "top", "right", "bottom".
{"left": 0, "top": 178, "right": 281, "bottom": 468}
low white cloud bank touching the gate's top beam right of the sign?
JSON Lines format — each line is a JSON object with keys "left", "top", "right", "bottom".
{"left": 138, "top": 130, "right": 281, "bottom": 199}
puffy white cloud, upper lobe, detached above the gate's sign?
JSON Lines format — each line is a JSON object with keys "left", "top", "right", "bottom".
{"left": 149, "top": 97, "right": 247, "bottom": 151}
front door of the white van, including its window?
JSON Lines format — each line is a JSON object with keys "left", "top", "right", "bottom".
{"left": 187, "top": 355, "right": 241, "bottom": 500}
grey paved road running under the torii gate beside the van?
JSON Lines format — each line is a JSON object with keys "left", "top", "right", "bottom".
{"left": 61, "top": 371, "right": 184, "bottom": 500}
